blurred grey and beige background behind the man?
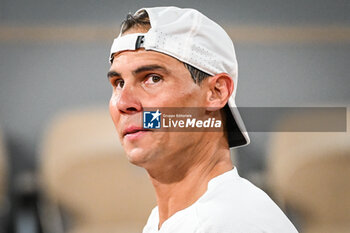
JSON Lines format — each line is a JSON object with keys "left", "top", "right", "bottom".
{"left": 0, "top": 0, "right": 350, "bottom": 233}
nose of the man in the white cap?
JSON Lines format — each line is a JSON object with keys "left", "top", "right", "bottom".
{"left": 117, "top": 86, "right": 142, "bottom": 114}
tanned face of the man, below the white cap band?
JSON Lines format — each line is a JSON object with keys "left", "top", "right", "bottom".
{"left": 108, "top": 49, "right": 207, "bottom": 167}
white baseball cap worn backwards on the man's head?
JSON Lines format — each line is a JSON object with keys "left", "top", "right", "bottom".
{"left": 109, "top": 7, "right": 250, "bottom": 148}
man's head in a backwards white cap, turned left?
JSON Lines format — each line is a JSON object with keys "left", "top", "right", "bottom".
{"left": 109, "top": 7, "right": 249, "bottom": 169}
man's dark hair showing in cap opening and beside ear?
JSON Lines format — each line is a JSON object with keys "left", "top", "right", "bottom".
{"left": 121, "top": 10, "right": 211, "bottom": 84}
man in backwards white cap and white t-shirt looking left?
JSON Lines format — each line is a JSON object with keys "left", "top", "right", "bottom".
{"left": 108, "top": 7, "right": 297, "bottom": 233}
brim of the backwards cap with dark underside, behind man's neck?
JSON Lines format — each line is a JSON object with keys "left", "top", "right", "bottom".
{"left": 224, "top": 96, "right": 250, "bottom": 148}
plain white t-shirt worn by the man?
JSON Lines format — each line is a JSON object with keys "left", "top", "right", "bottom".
{"left": 143, "top": 168, "right": 298, "bottom": 233}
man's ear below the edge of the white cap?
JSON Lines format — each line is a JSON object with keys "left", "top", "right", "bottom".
{"left": 207, "top": 73, "right": 234, "bottom": 111}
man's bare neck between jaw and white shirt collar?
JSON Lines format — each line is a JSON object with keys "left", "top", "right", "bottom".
{"left": 148, "top": 142, "right": 233, "bottom": 229}
